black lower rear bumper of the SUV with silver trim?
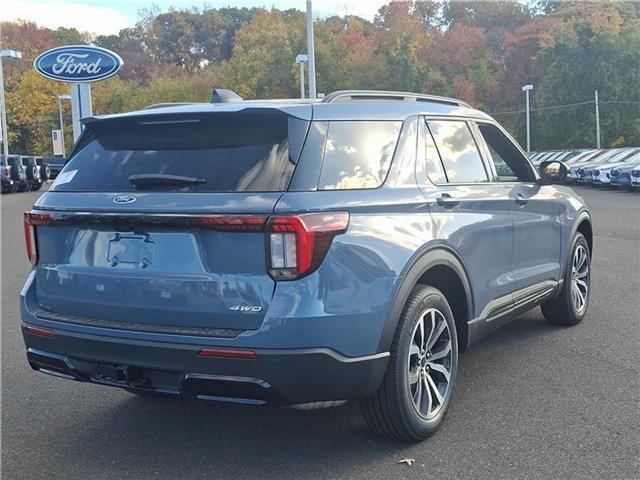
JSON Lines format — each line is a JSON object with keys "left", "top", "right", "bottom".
{"left": 22, "top": 322, "right": 388, "bottom": 405}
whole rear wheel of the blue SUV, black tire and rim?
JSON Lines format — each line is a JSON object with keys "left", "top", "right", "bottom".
{"left": 360, "top": 285, "right": 458, "bottom": 441}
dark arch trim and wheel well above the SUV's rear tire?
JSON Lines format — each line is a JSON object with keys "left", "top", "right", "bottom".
{"left": 378, "top": 245, "right": 473, "bottom": 351}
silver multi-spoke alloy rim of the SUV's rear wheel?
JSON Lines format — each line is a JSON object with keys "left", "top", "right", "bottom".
{"left": 407, "top": 308, "right": 453, "bottom": 418}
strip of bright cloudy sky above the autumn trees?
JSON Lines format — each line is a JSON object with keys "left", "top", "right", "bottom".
{"left": 0, "top": 0, "right": 388, "bottom": 35}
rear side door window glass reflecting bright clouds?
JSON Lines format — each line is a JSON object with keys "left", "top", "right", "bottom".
{"left": 429, "top": 120, "right": 488, "bottom": 183}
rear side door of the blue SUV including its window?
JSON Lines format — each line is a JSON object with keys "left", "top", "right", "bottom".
{"left": 418, "top": 118, "right": 514, "bottom": 318}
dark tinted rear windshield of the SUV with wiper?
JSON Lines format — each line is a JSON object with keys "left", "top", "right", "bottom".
{"left": 51, "top": 112, "right": 308, "bottom": 192}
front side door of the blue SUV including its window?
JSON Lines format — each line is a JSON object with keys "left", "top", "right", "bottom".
{"left": 475, "top": 122, "right": 563, "bottom": 303}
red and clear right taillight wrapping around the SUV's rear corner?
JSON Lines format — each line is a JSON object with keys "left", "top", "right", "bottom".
{"left": 266, "top": 212, "right": 349, "bottom": 280}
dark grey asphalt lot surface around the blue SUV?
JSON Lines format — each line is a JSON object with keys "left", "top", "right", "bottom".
{"left": 2, "top": 188, "right": 640, "bottom": 480}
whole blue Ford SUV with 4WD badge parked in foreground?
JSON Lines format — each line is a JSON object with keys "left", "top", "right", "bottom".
{"left": 21, "top": 91, "right": 593, "bottom": 440}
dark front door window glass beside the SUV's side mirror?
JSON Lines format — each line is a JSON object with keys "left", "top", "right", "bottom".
{"left": 478, "top": 123, "right": 534, "bottom": 182}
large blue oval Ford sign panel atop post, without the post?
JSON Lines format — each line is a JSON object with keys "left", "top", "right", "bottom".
{"left": 33, "top": 45, "right": 122, "bottom": 82}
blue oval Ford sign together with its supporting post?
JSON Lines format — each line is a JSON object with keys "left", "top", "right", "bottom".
{"left": 33, "top": 45, "right": 123, "bottom": 142}
